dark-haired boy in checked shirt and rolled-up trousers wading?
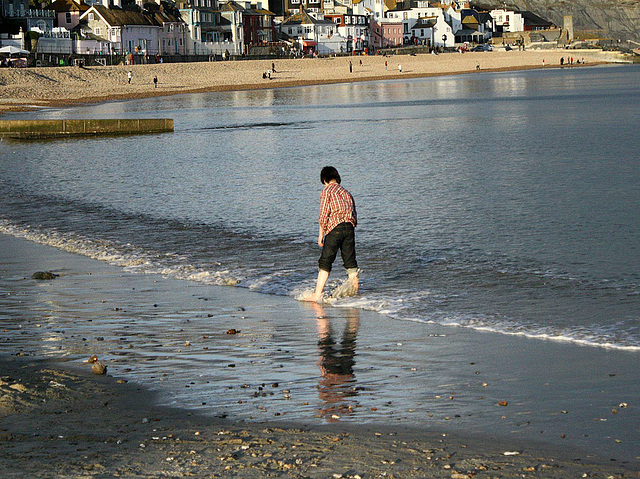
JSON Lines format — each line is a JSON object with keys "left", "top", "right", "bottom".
{"left": 306, "top": 166, "right": 359, "bottom": 302}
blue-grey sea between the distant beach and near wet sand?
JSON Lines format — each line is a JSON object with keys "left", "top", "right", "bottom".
{"left": 0, "top": 62, "right": 640, "bottom": 349}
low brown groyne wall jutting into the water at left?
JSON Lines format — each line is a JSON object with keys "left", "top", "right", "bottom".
{"left": 0, "top": 118, "right": 173, "bottom": 140}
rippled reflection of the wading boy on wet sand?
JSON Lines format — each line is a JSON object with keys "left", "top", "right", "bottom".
{"left": 313, "top": 303, "right": 360, "bottom": 421}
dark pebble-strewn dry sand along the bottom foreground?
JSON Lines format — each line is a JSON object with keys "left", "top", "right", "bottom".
{"left": 0, "top": 355, "right": 637, "bottom": 479}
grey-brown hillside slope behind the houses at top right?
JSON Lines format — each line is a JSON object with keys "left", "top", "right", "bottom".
{"left": 482, "top": 0, "right": 640, "bottom": 40}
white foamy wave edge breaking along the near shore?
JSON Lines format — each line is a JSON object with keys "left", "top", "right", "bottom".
{"left": 0, "top": 219, "right": 640, "bottom": 351}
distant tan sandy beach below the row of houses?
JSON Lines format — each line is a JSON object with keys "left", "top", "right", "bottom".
{"left": 0, "top": 50, "right": 613, "bottom": 111}
